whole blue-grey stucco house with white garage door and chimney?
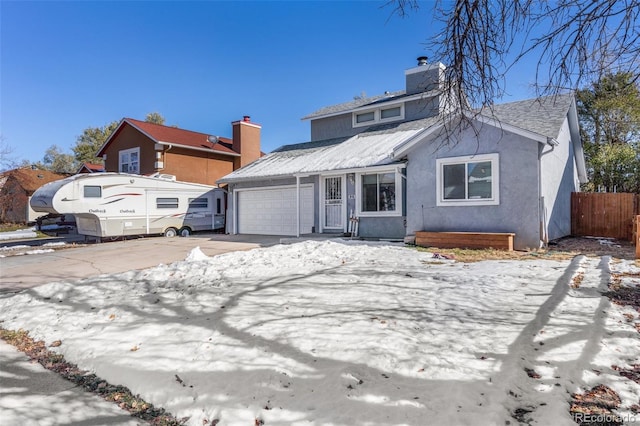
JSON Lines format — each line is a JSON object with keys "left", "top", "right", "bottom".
{"left": 218, "top": 58, "right": 586, "bottom": 249}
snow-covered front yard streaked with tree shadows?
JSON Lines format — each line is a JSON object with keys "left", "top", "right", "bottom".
{"left": 0, "top": 241, "right": 640, "bottom": 425}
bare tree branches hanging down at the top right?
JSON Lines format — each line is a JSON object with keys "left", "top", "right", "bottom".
{"left": 388, "top": 0, "right": 640, "bottom": 107}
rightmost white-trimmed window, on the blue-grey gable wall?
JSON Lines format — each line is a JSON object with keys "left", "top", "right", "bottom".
{"left": 436, "top": 154, "right": 500, "bottom": 206}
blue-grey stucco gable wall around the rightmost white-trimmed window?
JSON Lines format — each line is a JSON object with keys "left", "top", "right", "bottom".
{"left": 407, "top": 121, "right": 540, "bottom": 249}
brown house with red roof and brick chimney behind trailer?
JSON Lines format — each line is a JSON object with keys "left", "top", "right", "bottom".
{"left": 97, "top": 116, "right": 261, "bottom": 185}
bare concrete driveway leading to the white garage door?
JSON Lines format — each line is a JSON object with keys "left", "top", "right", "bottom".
{"left": 0, "top": 234, "right": 281, "bottom": 293}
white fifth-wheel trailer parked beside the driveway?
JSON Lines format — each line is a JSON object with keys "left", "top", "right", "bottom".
{"left": 30, "top": 173, "right": 225, "bottom": 240}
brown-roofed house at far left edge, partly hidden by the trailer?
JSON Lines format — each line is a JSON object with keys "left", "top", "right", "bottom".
{"left": 0, "top": 167, "right": 68, "bottom": 223}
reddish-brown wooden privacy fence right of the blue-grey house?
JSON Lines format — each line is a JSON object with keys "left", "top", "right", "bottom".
{"left": 571, "top": 192, "right": 640, "bottom": 241}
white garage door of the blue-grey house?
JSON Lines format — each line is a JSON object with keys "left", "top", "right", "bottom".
{"left": 237, "top": 185, "right": 313, "bottom": 235}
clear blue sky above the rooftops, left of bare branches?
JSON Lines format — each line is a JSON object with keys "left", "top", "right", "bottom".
{"left": 0, "top": 0, "right": 531, "bottom": 162}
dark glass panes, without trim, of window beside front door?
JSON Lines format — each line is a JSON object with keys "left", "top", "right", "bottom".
{"left": 360, "top": 172, "right": 397, "bottom": 212}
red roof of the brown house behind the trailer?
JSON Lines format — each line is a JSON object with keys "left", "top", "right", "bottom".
{"left": 98, "top": 118, "right": 238, "bottom": 156}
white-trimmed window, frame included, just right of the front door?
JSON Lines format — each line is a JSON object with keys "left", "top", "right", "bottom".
{"left": 357, "top": 170, "right": 402, "bottom": 216}
